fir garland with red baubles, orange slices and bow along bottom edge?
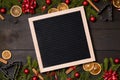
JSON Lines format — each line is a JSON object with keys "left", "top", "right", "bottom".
{"left": 0, "top": 56, "right": 120, "bottom": 80}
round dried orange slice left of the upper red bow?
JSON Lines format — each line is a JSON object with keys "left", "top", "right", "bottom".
{"left": 10, "top": 5, "right": 22, "bottom": 17}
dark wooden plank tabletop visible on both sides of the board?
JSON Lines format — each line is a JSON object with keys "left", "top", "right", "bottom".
{"left": 0, "top": 6, "right": 120, "bottom": 63}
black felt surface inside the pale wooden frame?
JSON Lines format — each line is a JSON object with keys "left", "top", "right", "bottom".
{"left": 34, "top": 12, "right": 90, "bottom": 67}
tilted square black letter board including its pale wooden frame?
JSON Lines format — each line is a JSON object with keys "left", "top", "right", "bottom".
{"left": 29, "top": 7, "right": 95, "bottom": 72}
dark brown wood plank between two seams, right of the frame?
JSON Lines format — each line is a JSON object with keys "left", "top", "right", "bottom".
{"left": 91, "top": 29, "right": 120, "bottom": 50}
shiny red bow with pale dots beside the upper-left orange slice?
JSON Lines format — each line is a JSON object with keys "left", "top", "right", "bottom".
{"left": 22, "top": 0, "right": 37, "bottom": 14}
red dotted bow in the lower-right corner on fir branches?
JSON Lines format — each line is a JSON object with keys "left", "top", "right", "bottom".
{"left": 103, "top": 70, "right": 119, "bottom": 80}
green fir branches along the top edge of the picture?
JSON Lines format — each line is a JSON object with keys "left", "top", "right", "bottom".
{"left": 0, "top": 0, "right": 97, "bottom": 18}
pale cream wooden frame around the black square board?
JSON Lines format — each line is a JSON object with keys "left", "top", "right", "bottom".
{"left": 28, "top": 6, "right": 95, "bottom": 73}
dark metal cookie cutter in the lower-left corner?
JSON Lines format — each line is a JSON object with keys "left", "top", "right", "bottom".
{"left": 0, "top": 62, "right": 22, "bottom": 80}
